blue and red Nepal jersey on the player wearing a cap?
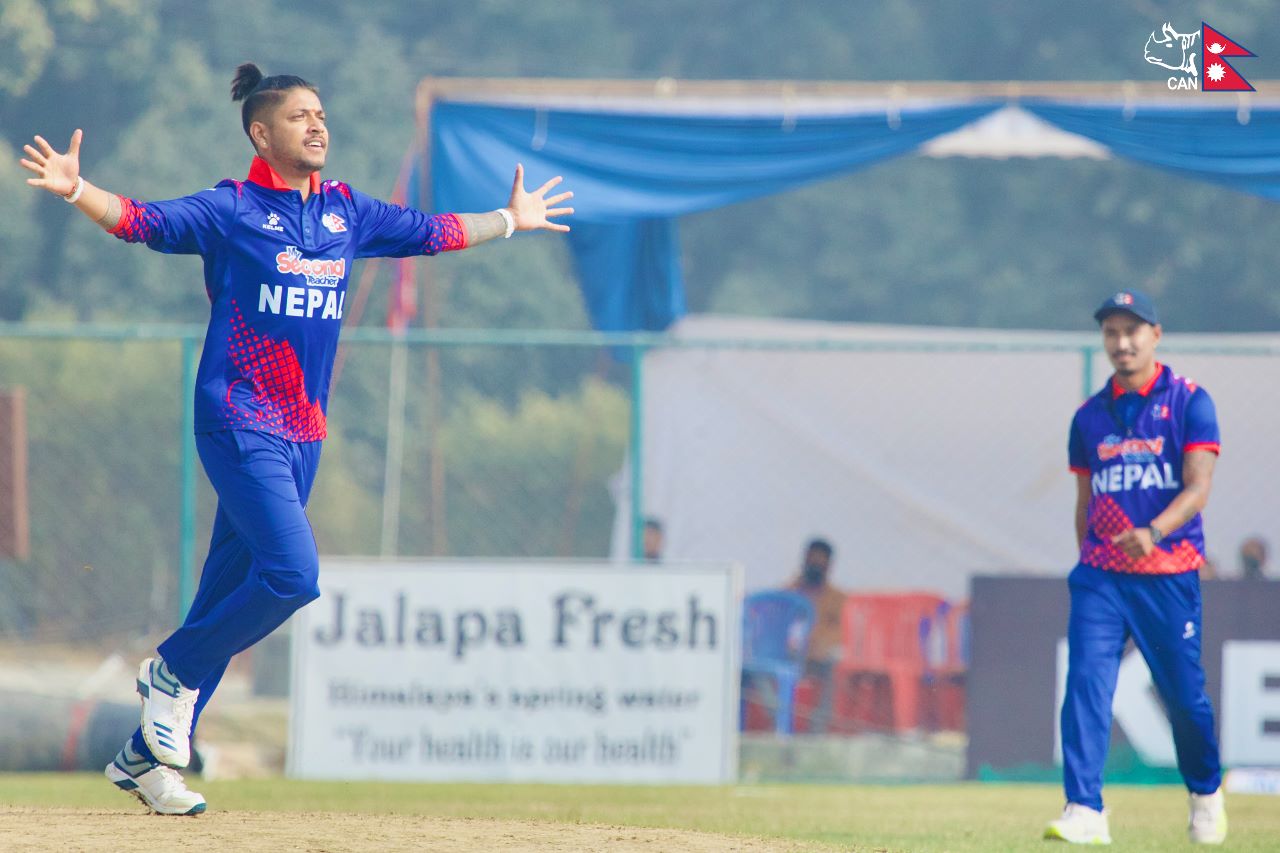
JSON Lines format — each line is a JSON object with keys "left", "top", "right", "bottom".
{"left": 1069, "top": 364, "right": 1220, "bottom": 575}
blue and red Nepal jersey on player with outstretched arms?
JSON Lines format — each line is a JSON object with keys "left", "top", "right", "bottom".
{"left": 111, "top": 158, "right": 467, "bottom": 442}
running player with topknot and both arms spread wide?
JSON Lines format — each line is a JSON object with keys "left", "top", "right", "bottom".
{"left": 20, "top": 63, "right": 573, "bottom": 815}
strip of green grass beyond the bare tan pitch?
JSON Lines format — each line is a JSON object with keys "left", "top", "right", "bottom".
{"left": 0, "top": 774, "right": 1280, "bottom": 853}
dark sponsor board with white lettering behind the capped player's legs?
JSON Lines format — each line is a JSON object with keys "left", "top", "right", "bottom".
{"left": 965, "top": 576, "right": 1280, "bottom": 780}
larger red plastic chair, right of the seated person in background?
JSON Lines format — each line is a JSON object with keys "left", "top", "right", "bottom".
{"left": 835, "top": 593, "right": 946, "bottom": 731}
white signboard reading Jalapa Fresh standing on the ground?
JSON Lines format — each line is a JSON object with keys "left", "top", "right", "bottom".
{"left": 288, "top": 558, "right": 741, "bottom": 783}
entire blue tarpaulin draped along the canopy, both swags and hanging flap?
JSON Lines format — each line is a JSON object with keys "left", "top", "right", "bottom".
{"left": 410, "top": 100, "right": 1280, "bottom": 330}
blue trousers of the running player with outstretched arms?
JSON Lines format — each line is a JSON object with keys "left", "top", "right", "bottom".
{"left": 133, "top": 430, "right": 320, "bottom": 761}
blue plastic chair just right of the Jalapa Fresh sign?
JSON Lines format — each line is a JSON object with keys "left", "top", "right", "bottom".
{"left": 740, "top": 589, "right": 814, "bottom": 734}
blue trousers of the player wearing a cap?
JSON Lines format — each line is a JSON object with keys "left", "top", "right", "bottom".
{"left": 1062, "top": 565, "right": 1222, "bottom": 811}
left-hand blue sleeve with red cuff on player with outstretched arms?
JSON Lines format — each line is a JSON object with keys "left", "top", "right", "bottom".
{"left": 111, "top": 187, "right": 236, "bottom": 255}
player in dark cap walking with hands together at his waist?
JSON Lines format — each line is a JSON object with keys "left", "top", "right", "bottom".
{"left": 1044, "top": 291, "right": 1226, "bottom": 844}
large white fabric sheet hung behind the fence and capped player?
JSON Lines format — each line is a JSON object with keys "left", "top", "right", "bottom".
{"left": 614, "top": 316, "right": 1280, "bottom": 597}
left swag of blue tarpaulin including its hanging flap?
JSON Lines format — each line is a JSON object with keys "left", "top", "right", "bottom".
{"left": 411, "top": 101, "right": 1000, "bottom": 326}
